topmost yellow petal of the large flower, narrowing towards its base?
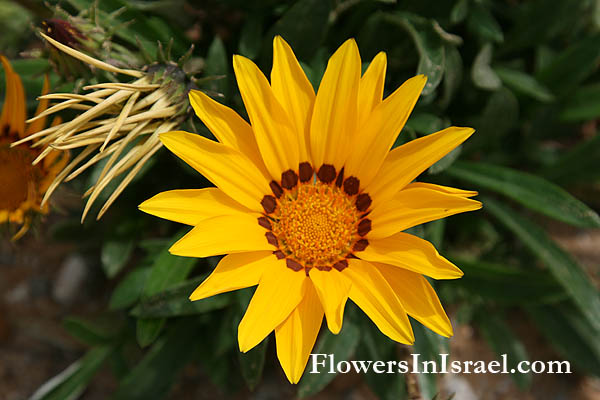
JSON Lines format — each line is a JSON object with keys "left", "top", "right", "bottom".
{"left": 271, "top": 36, "right": 315, "bottom": 162}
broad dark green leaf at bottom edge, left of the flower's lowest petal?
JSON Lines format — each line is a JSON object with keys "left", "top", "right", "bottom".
{"left": 113, "top": 320, "right": 199, "bottom": 400}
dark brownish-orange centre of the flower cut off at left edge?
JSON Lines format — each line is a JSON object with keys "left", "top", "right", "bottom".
{"left": 0, "top": 143, "right": 35, "bottom": 211}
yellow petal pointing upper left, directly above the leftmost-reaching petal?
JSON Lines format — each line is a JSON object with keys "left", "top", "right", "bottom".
{"left": 160, "top": 131, "right": 271, "bottom": 212}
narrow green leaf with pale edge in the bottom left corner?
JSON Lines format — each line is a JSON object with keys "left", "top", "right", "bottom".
{"left": 29, "top": 346, "right": 113, "bottom": 400}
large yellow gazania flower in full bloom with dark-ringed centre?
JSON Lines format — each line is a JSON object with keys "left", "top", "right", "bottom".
{"left": 140, "top": 37, "right": 481, "bottom": 383}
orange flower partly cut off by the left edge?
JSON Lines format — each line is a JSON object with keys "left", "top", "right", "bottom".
{"left": 0, "top": 55, "right": 68, "bottom": 239}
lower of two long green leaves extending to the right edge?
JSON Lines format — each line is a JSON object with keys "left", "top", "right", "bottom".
{"left": 483, "top": 198, "right": 600, "bottom": 330}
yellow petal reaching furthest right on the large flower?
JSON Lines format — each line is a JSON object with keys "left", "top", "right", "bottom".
{"left": 369, "top": 185, "right": 481, "bottom": 239}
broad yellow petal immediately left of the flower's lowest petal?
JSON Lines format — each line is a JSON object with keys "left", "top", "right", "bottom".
{"left": 238, "top": 257, "right": 307, "bottom": 353}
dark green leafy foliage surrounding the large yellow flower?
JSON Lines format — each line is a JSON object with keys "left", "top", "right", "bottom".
{"left": 0, "top": 0, "right": 600, "bottom": 399}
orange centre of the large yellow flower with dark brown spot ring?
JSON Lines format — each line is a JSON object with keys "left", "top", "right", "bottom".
{"left": 258, "top": 163, "right": 371, "bottom": 273}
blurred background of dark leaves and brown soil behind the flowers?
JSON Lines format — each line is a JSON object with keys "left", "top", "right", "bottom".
{"left": 0, "top": 0, "right": 600, "bottom": 400}
